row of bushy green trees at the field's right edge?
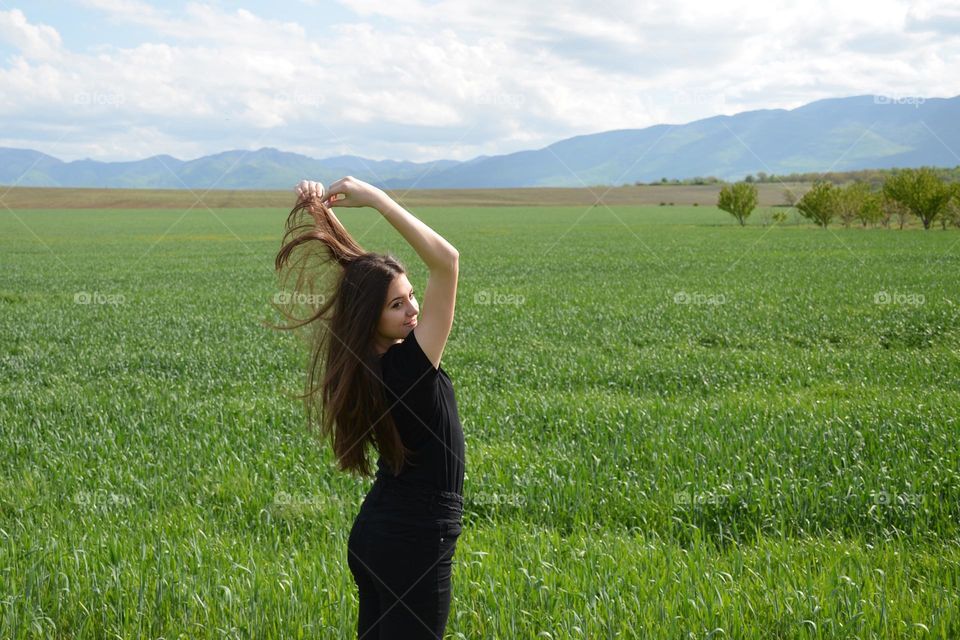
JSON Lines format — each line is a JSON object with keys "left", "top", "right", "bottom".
{"left": 717, "top": 167, "right": 960, "bottom": 229}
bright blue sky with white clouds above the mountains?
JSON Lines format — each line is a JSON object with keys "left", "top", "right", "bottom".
{"left": 0, "top": 0, "right": 960, "bottom": 162}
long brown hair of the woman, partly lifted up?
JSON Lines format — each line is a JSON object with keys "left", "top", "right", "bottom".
{"left": 271, "top": 198, "right": 412, "bottom": 476}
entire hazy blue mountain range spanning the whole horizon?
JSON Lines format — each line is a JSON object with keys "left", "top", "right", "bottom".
{"left": 0, "top": 96, "right": 960, "bottom": 190}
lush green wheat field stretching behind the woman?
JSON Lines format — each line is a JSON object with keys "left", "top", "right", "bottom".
{"left": 0, "top": 201, "right": 960, "bottom": 640}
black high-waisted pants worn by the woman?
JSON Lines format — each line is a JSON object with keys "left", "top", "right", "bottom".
{"left": 347, "top": 478, "right": 463, "bottom": 640}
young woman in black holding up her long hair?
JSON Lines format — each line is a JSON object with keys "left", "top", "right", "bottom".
{"left": 276, "top": 176, "right": 464, "bottom": 640}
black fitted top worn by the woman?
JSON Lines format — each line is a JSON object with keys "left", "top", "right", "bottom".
{"left": 376, "top": 328, "right": 465, "bottom": 495}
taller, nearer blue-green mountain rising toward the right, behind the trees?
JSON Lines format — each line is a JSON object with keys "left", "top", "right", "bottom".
{"left": 388, "top": 96, "right": 960, "bottom": 188}
